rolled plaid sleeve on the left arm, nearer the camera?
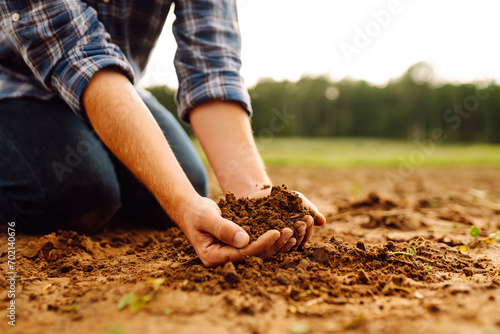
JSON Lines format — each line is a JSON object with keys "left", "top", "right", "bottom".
{"left": 0, "top": 0, "right": 134, "bottom": 118}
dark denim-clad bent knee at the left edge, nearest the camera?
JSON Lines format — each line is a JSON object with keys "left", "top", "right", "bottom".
{"left": 0, "top": 99, "right": 120, "bottom": 233}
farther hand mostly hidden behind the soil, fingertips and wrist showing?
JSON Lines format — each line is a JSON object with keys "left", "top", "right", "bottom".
{"left": 248, "top": 188, "right": 326, "bottom": 252}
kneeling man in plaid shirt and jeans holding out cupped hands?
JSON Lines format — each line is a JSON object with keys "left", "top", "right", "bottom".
{"left": 0, "top": 0, "right": 325, "bottom": 266}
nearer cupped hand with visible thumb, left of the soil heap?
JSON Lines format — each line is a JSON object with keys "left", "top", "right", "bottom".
{"left": 178, "top": 197, "right": 296, "bottom": 267}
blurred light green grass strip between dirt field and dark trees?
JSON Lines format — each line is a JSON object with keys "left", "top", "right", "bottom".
{"left": 195, "top": 137, "right": 500, "bottom": 167}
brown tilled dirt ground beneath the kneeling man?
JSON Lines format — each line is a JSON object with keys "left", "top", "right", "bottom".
{"left": 0, "top": 168, "right": 500, "bottom": 334}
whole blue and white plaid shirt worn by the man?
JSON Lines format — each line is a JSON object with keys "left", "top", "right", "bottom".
{"left": 0, "top": 0, "right": 251, "bottom": 122}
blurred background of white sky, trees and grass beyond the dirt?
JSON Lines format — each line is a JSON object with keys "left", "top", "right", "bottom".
{"left": 142, "top": 0, "right": 500, "bottom": 166}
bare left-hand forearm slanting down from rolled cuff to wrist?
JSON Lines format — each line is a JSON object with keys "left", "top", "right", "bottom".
{"left": 83, "top": 69, "right": 198, "bottom": 223}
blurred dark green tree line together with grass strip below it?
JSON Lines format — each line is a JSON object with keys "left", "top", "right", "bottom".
{"left": 148, "top": 63, "right": 500, "bottom": 167}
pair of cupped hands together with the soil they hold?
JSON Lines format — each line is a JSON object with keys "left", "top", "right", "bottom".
{"left": 178, "top": 187, "right": 325, "bottom": 267}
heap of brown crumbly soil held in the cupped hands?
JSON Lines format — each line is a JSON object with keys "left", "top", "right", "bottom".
{"left": 218, "top": 185, "right": 314, "bottom": 241}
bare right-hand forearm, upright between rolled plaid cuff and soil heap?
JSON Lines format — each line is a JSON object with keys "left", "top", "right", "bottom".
{"left": 189, "top": 101, "right": 271, "bottom": 196}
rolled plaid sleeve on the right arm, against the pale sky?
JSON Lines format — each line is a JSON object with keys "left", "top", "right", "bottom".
{"left": 173, "top": 0, "right": 252, "bottom": 123}
